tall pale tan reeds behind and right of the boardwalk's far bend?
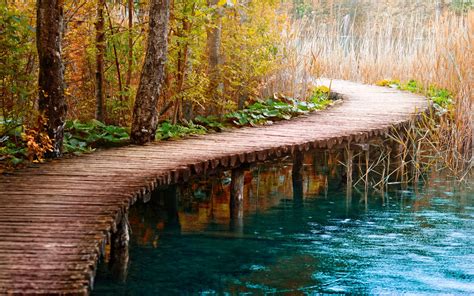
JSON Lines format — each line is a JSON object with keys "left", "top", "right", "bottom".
{"left": 280, "top": 1, "right": 474, "bottom": 179}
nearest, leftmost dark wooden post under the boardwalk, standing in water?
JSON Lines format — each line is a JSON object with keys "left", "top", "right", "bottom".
{"left": 109, "top": 212, "right": 130, "bottom": 281}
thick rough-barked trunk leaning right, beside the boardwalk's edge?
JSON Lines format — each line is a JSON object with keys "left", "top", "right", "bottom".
{"left": 131, "top": 0, "right": 170, "bottom": 144}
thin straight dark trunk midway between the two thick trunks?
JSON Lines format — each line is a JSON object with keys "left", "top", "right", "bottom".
{"left": 95, "top": 0, "right": 105, "bottom": 122}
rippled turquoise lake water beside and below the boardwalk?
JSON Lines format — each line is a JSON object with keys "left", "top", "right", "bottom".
{"left": 93, "top": 155, "right": 474, "bottom": 295}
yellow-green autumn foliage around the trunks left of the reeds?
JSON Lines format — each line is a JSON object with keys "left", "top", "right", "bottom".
{"left": 0, "top": 0, "right": 300, "bottom": 166}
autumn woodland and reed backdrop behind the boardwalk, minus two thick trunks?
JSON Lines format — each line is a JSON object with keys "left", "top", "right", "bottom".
{"left": 0, "top": 0, "right": 474, "bottom": 173}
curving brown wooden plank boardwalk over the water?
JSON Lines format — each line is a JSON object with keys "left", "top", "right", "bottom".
{"left": 0, "top": 81, "right": 428, "bottom": 294}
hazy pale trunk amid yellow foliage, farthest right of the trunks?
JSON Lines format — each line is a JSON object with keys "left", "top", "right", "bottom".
{"left": 207, "top": 0, "right": 222, "bottom": 114}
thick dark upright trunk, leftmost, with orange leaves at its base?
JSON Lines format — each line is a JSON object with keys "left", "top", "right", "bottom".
{"left": 36, "top": 0, "right": 67, "bottom": 157}
